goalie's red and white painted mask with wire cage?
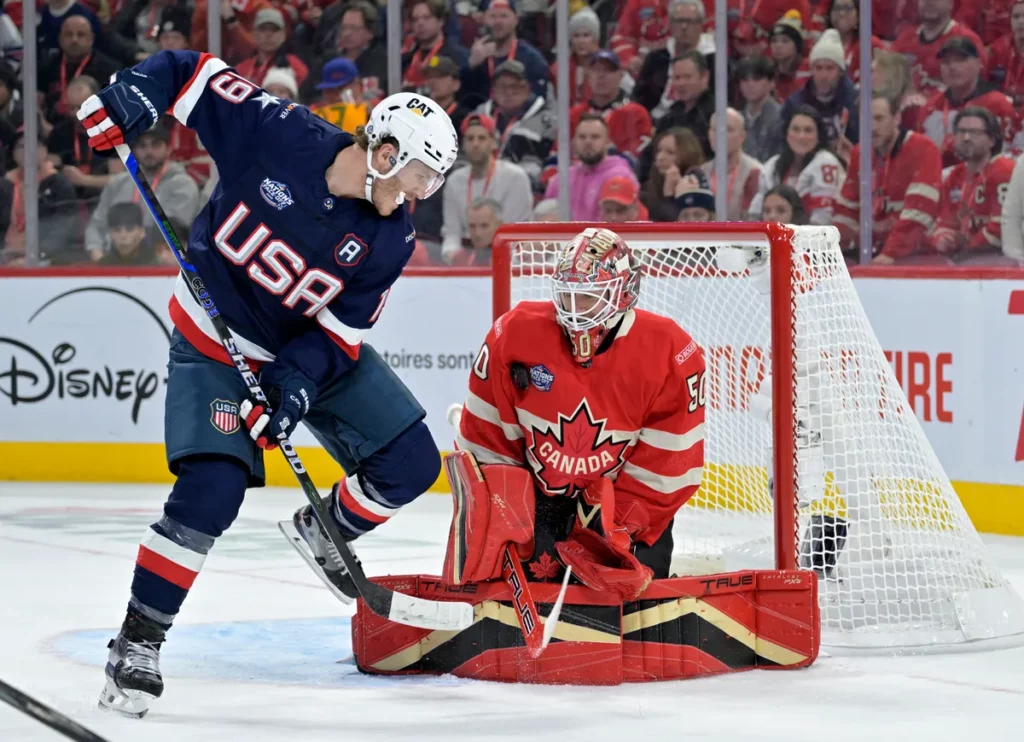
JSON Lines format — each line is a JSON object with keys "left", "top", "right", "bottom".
{"left": 551, "top": 229, "right": 641, "bottom": 366}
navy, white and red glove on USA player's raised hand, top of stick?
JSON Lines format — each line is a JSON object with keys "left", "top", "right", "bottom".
{"left": 78, "top": 70, "right": 170, "bottom": 151}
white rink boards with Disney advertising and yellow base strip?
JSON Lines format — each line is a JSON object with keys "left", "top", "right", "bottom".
{"left": 0, "top": 269, "right": 1024, "bottom": 534}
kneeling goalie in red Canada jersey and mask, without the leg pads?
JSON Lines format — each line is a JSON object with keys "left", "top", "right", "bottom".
{"left": 445, "top": 228, "right": 705, "bottom": 600}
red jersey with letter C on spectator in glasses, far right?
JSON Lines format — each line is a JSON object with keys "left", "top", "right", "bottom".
{"left": 933, "top": 156, "right": 1015, "bottom": 250}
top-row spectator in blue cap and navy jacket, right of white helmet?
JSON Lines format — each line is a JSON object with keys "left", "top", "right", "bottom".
{"left": 462, "top": 0, "right": 548, "bottom": 105}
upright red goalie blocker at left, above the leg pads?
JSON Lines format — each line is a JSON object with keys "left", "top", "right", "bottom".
{"left": 442, "top": 451, "right": 536, "bottom": 584}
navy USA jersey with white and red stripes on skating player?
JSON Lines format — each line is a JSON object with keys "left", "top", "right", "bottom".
{"left": 135, "top": 51, "right": 415, "bottom": 386}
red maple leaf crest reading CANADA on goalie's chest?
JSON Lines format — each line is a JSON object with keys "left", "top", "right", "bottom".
{"left": 526, "top": 397, "right": 631, "bottom": 495}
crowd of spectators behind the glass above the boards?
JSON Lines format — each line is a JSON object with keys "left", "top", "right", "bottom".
{"left": 0, "top": 0, "right": 1024, "bottom": 266}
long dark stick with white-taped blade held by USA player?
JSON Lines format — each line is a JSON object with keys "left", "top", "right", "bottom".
{"left": 117, "top": 144, "right": 473, "bottom": 630}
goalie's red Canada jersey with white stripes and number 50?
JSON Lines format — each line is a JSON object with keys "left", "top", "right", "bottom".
{"left": 456, "top": 302, "right": 707, "bottom": 544}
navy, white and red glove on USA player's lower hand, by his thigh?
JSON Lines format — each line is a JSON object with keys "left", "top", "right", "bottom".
{"left": 239, "top": 363, "right": 316, "bottom": 450}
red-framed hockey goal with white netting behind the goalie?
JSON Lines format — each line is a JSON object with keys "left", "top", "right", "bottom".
{"left": 494, "top": 223, "right": 1024, "bottom": 651}
